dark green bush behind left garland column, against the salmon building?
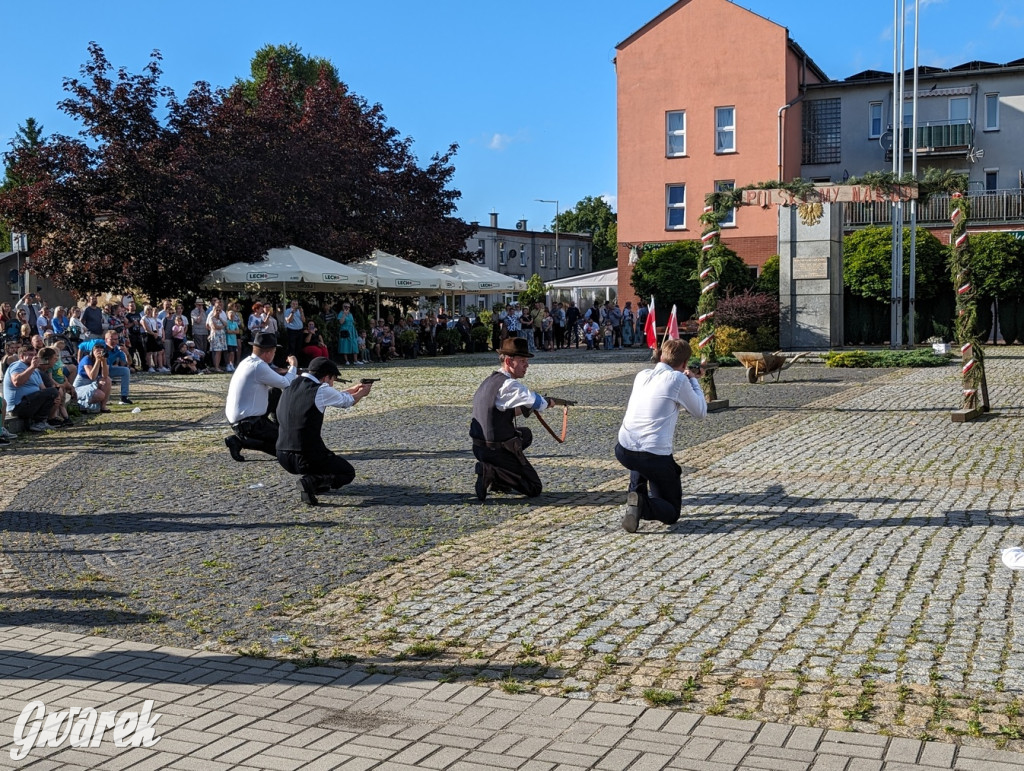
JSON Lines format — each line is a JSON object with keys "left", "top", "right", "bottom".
{"left": 631, "top": 240, "right": 751, "bottom": 323}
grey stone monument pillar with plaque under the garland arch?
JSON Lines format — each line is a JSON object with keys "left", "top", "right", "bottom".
{"left": 778, "top": 204, "right": 843, "bottom": 350}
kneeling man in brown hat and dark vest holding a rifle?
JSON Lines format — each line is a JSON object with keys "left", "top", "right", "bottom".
{"left": 469, "top": 337, "right": 552, "bottom": 501}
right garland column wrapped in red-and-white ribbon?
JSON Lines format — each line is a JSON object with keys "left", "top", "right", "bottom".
{"left": 949, "top": 190, "right": 988, "bottom": 412}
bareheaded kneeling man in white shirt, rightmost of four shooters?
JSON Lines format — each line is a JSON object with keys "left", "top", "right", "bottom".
{"left": 615, "top": 340, "right": 708, "bottom": 532}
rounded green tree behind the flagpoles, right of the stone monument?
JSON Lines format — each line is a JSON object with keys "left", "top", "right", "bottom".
{"left": 843, "top": 226, "right": 949, "bottom": 302}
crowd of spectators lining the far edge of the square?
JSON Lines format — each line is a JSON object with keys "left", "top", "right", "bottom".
{"left": 0, "top": 286, "right": 647, "bottom": 443}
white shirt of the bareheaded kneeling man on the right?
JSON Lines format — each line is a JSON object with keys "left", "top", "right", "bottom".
{"left": 618, "top": 361, "right": 708, "bottom": 455}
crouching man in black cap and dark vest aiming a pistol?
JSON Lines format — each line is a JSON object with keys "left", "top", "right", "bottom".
{"left": 278, "top": 356, "right": 373, "bottom": 506}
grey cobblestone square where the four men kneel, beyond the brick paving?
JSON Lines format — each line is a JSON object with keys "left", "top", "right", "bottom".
{"left": 6, "top": 350, "right": 1024, "bottom": 769}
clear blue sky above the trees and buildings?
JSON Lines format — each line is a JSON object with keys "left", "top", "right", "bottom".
{"left": 0, "top": 0, "right": 1024, "bottom": 229}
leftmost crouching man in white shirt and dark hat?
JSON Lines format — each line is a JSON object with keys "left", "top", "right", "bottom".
{"left": 224, "top": 332, "right": 299, "bottom": 462}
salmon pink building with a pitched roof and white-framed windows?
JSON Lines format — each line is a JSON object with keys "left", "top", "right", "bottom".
{"left": 614, "top": 0, "right": 828, "bottom": 300}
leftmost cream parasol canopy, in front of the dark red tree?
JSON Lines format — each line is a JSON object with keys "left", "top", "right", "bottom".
{"left": 202, "top": 246, "right": 376, "bottom": 292}
